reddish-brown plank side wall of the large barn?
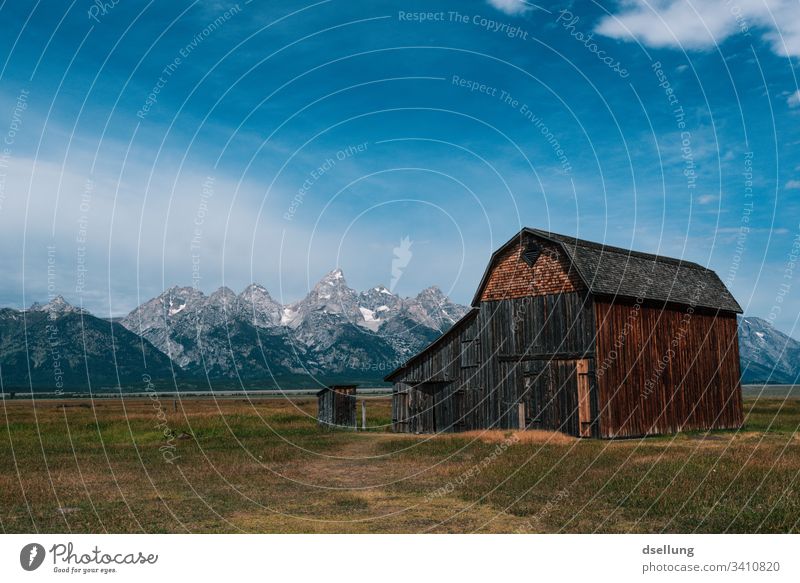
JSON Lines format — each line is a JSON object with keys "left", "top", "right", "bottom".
{"left": 595, "top": 298, "right": 742, "bottom": 437}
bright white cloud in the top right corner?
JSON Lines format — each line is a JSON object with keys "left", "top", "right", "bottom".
{"left": 595, "top": 0, "right": 800, "bottom": 57}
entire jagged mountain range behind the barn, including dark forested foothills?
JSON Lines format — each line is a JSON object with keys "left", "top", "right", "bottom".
{"left": 0, "top": 269, "right": 800, "bottom": 390}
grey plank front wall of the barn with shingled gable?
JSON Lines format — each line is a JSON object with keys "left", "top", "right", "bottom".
{"left": 392, "top": 237, "right": 594, "bottom": 435}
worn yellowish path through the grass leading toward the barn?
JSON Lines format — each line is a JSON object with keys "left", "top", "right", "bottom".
{"left": 222, "top": 433, "right": 530, "bottom": 532}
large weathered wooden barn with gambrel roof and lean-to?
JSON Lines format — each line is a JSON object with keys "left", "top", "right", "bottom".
{"left": 386, "top": 229, "right": 742, "bottom": 438}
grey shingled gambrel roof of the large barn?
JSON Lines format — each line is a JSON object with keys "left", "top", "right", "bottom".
{"left": 472, "top": 228, "right": 742, "bottom": 314}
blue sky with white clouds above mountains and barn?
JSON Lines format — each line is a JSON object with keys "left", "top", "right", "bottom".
{"left": 0, "top": 0, "right": 800, "bottom": 336}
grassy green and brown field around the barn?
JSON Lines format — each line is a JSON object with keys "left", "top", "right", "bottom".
{"left": 0, "top": 398, "right": 800, "bottom": 533}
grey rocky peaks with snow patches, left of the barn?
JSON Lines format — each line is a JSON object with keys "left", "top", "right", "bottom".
{"left": 115, "top": 276, "right": 466, "bottom": 377}
